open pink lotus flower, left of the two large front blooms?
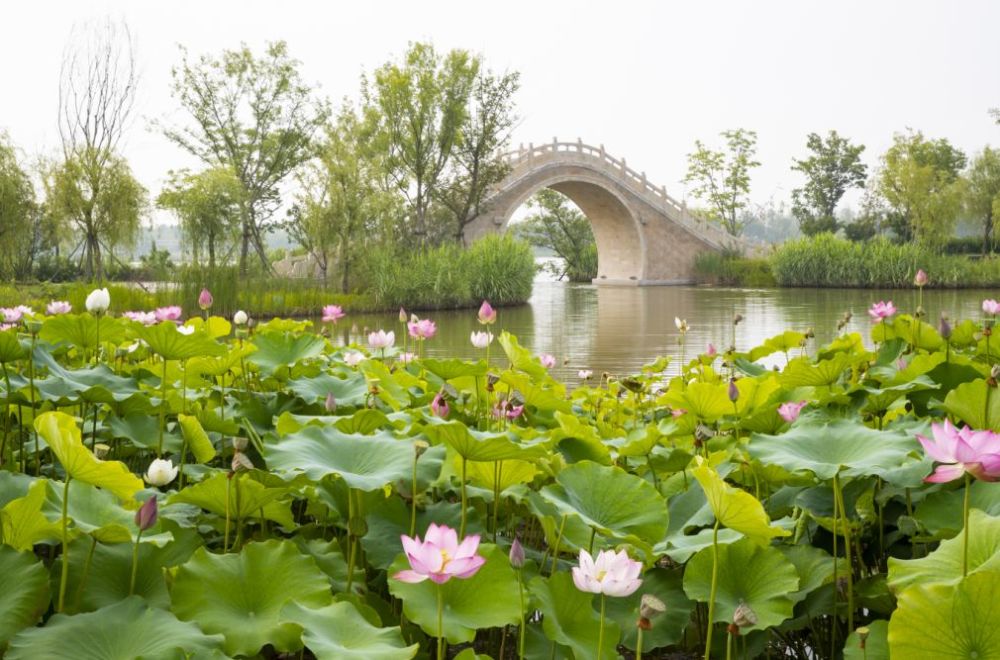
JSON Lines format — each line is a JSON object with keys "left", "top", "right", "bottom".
{"left": 392, "top": 523, "right": 486, "bottom": 584}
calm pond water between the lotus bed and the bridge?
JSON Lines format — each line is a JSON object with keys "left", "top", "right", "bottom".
{"left": 337, "top": 279, "right": 1000, "bottom": 382}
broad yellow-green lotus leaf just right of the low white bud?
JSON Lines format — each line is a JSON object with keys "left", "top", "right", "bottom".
{"left": 168, "top": 472, "right": 295, "bottom": 529}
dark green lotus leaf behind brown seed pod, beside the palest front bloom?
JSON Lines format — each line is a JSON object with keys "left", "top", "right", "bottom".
{"left": 595, "top": 568, "right": 694, "bottom": 657}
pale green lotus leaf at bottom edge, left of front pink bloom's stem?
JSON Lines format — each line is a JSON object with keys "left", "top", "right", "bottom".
{"left": 281, "top": 601, "right": 420, "bottom": 660}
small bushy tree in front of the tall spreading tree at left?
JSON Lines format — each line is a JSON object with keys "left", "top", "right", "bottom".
{"left": 156, "top": 166, "right": 243, "bottom": 268}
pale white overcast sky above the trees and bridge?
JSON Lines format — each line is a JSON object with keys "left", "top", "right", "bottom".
{"left": 0, "top": 0, "right": 1000, "bottom": 222}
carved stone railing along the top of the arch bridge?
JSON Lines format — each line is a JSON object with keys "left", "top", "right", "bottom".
{"left": 501, "top": 138, "right": 745, "bottom": 247}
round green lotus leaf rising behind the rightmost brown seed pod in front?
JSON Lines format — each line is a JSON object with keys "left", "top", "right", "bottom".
{"left": 684, "top": 539, "right": 799, "bottom": 630}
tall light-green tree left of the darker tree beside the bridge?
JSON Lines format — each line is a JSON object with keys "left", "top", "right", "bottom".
{"left": 362, "top": 43, "right": 480, "bottom": 244}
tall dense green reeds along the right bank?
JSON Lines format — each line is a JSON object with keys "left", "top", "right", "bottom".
{"left": 770, "top": 234, "right": 1000, "bottom": 288}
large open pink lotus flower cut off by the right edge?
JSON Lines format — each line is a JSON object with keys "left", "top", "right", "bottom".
{"left": 917, "top": 420, "right": 1000, "bottom": 483}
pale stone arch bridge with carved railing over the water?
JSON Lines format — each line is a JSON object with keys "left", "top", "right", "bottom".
{"left": 465, "top": 140, "right": 746, "bottom": 286}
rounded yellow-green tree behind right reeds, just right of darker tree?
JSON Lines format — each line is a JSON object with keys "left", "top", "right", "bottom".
{"left": 878, "top": 131, "right": 966, "bottom": 245}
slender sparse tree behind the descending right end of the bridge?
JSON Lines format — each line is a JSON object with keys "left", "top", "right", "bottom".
{"left": 684, "top": 128, "right": 760, "bottom": 236}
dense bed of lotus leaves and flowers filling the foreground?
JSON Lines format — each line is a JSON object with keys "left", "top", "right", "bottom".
{"left": 0, "top": 300, "right": 1000, "bottom": 660}
